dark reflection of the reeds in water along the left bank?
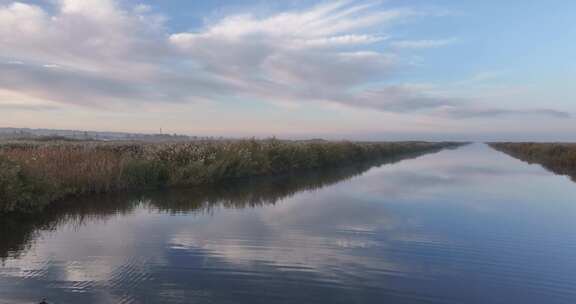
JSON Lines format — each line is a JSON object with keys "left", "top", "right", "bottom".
{"left": 0, "top": 151, "right": 446, "bottom": 264}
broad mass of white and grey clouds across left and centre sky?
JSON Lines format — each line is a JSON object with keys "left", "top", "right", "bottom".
{"left": 0, "top": 0, "right": 568, "bottom": 119}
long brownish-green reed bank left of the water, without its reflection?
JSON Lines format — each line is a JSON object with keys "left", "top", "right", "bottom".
{"left": 0, "top": 139, "right": 461, "bottom": 213}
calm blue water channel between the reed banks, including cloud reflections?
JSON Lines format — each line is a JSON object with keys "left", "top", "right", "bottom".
{"left": 0, "top": 145, "right": 576, "bottom": 304}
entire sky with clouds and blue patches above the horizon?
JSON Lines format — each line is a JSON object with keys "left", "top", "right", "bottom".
{"left": 0, "top": 0, "right": 576, "bottom": 141}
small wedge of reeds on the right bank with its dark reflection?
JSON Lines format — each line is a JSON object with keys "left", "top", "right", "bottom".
{"left": 490, "top": 142, "right": 576, "bottom": 182}
